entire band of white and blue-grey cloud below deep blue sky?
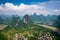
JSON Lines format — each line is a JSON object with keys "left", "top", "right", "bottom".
{"left": 0, "top": 0, "right": 60, "bottom": 16}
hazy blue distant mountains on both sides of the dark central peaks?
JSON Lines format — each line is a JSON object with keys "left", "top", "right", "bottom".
{"left": 0, "top": 13, "right": 57, "bottom": 25}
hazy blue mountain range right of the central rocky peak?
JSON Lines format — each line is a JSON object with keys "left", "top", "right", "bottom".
{"left": 30, "top": 13, "right": 57, "bottom": 25}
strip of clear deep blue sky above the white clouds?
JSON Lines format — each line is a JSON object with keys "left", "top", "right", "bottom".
{"left": 0, "top": 0, "right": 50, "bottom": 5}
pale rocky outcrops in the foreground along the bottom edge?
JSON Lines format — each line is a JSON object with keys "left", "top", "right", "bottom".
{"left": 13, "top": 34, "right": 54, "bottom": 40}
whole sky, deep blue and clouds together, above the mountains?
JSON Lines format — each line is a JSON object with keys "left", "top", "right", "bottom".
{"left": 0, "top": 0, "right": 60, "bottom": 16}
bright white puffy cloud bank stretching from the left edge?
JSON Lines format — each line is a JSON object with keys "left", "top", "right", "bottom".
{"left": 0, "top": 3, "right": 46, "bottom": 15}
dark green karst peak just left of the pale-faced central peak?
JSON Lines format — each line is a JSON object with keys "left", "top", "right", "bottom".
{"left": 9, "top": 15, "right": 21, "bottom": 27}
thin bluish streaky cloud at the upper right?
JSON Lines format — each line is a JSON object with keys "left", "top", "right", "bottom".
{"left": 37, "top": 0, "right": 60, "bottom": 15}
